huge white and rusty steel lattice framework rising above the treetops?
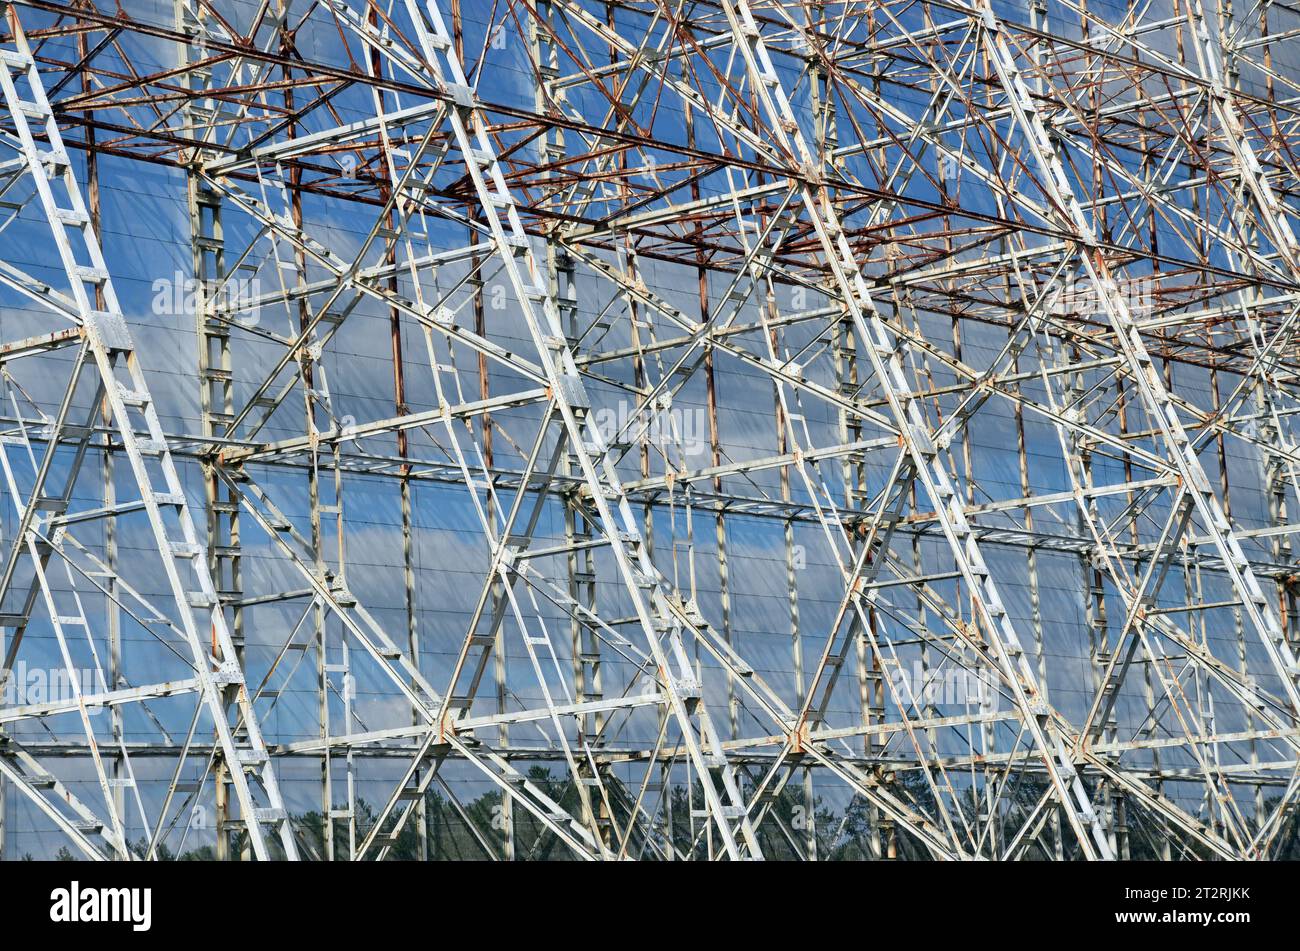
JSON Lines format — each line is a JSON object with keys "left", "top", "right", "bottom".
{"left": 0, "top": 0, "right": 1300, "bottom": 860}
